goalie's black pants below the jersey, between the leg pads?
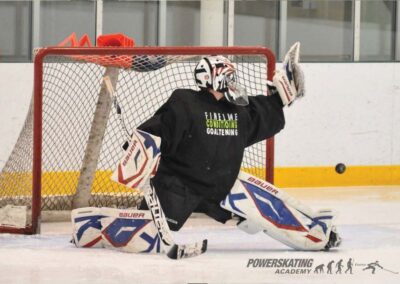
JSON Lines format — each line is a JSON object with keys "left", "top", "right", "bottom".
{"left": 139, "top": 176, "right": 232, "bottom": 231}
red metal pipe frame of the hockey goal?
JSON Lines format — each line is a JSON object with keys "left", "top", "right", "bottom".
{"left": 0, "top": 46, "right": 276, "bottom": 234}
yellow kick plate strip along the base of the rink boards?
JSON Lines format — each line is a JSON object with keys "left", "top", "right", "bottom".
{"left": 0, "top": 166, "right": 400, "bottom": 198}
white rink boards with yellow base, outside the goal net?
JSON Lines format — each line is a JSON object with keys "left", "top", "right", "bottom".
{"left": 0, "top": 63, "right": 400, "bottom": 187}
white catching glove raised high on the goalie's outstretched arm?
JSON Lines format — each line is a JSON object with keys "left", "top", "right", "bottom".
{"left": 273, "top": 42, "right": 305, "bottom": 106}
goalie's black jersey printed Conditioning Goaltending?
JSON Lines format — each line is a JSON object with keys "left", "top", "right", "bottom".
{"left": 138, "top": 89, "right": 285, "bottom": 201}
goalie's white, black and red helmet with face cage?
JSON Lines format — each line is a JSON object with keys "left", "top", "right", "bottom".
{"left": 194, "top": 56, "right": 249, "bottom": 105}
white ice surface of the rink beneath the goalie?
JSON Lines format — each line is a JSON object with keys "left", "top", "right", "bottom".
{"left": 0, "top": 187, "right": 400, "bottom": 284}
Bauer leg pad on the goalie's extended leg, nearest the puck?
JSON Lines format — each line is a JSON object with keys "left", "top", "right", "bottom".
{"left": 221, "top": 172, "right": 333, "bottom": 250}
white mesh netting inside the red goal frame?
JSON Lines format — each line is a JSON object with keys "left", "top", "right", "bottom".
{"left": 0, "top": 47, "right": 272, "bottom": 232}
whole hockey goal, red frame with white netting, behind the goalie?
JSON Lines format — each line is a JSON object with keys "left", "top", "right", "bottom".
{"left": 0, "top": 47, "right": 275, "bottom": 234}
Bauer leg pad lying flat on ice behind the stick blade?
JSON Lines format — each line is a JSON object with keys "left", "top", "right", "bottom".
{"left": 72, "top": 207, "right": 161, "bottom": 253}
